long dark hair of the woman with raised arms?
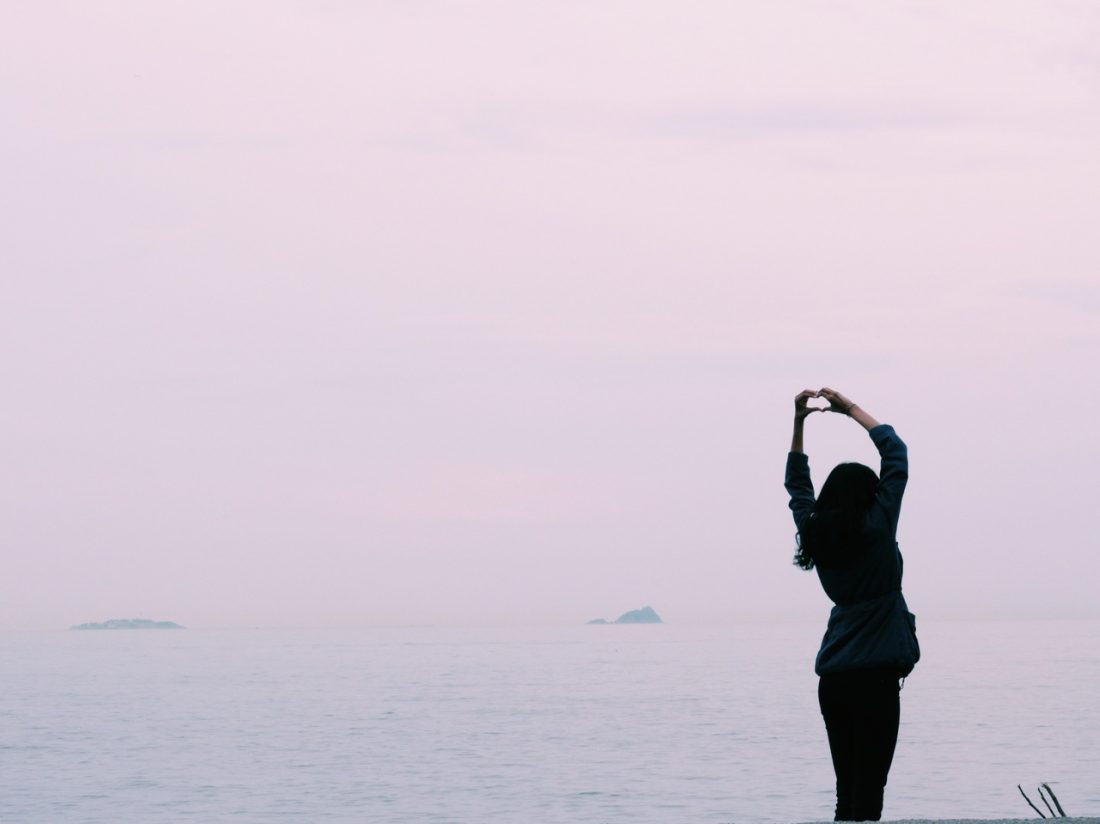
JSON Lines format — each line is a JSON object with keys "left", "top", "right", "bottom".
{"left": 794, "top": 463, "right": 879, "bottom": 570}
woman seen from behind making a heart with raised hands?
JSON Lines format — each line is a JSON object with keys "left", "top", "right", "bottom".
{"left": 784, "top": 387, "right": 921, "bottom": 821}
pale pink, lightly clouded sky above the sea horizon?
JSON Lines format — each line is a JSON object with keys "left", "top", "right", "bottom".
{"left": 0, "top": 0, "right": 1100, "bottom": 628}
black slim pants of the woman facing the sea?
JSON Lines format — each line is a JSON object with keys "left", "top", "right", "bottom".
{"left": 817, "top": 670, "right": 901, "bottom": 821}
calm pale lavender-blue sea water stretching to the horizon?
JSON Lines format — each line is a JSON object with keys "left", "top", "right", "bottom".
{"left": 0, "top": 622, "right": 1100, "bottom": 824}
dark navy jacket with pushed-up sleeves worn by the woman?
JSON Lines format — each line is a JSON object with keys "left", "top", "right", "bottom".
{"left": 785, "top": 424, "right": 921, "bottom": 675}
